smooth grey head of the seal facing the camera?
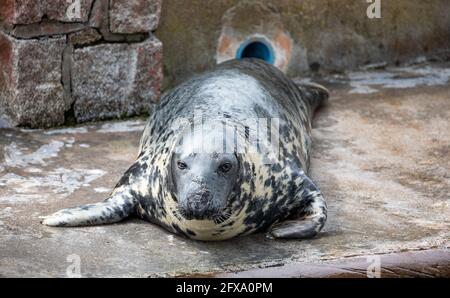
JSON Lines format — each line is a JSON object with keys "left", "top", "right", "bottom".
{"left": 171, "top": 124, "right": 240, "bottom": 220}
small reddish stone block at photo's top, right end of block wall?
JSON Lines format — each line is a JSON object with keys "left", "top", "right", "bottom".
{"left": 109, "top": 0, "right": 162, "bottom": 33}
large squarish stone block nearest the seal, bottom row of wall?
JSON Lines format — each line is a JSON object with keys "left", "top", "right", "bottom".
{"left": 72, "top": 36, "right": 162, "bottom": 122}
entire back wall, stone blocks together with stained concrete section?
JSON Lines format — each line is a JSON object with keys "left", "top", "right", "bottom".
{"left": 0, "top": 0, "right": 450, "bottom": 127}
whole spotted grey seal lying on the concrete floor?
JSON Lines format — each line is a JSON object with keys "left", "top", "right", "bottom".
{"left": 42, "top": 59, "right": 328, "bottom": 241}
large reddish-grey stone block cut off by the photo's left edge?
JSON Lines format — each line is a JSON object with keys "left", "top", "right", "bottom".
{"left": 0, "top": 33, "right": 66, "bottom": 127}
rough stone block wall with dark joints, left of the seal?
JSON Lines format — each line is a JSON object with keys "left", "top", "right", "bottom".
{"left": 0, "top": 0, "right": 162, "bottom": 127}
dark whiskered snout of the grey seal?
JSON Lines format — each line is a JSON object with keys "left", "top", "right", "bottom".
{"left": 185, "top": 190, "right": 214, "bottom": 219}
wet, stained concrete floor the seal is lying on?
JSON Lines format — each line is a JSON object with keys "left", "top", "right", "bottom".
{"left": 0, "top": 64, "right": 450, "bottom": 277}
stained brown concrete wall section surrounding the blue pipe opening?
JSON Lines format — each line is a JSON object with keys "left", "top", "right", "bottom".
{"left": 156, "top": 0, "right": 450, "bottom": 88}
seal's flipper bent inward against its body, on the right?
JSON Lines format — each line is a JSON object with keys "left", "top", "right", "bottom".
{"left": 270, "top": 174, "right": 327, "bottom": 239}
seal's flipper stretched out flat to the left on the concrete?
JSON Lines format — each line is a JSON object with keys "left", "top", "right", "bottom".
{"left": 42, "top": 188, "right": 137, "bottom": 227}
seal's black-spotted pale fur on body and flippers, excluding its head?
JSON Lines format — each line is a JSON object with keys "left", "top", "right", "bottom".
{"left": 43, "top": 59, "right": 328, "bottom": 240}
